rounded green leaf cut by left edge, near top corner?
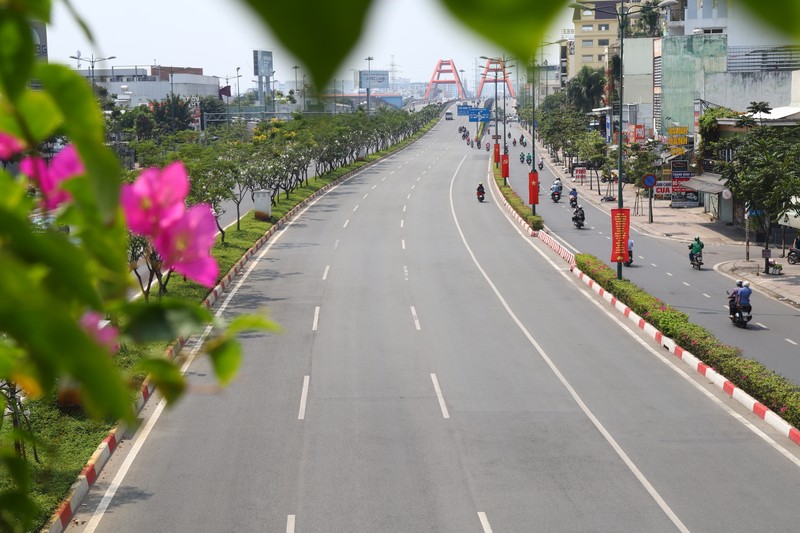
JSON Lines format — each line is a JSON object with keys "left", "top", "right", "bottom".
{"left": 0, "top": 12, "right": 34, "bottom": 100}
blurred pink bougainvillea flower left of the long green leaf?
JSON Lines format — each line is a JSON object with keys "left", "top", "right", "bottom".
{"left": 19, "top": 145, "right": 85, "bottom": 211}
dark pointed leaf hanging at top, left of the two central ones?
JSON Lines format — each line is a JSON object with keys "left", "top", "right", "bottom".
{"left": 239, "top": 0, "right": 372, "bottom": 88}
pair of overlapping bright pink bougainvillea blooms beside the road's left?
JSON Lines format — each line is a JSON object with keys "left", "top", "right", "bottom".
{"left": 120, "top": 161, "right": 219, "bottom": 287}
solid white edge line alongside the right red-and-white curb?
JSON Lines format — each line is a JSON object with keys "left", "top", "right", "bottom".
{"left": 488, "top": 169, "right": 800, "bottom": 468}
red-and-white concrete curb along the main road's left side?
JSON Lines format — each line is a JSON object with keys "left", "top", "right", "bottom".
{"left": 42, "top": 147, "right": 400, "bottom": 533}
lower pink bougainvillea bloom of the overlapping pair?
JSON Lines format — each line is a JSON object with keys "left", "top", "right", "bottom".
{"left": 153, "top": 204, "right": 219, "bottom": 287}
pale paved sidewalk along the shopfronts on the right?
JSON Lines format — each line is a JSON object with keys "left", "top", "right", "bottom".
{"left": 536, "top": 139, "right": 800, "bottom": 308}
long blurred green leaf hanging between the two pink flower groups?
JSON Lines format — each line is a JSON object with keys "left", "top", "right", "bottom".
{"left": 35, "top": 63, "right": 121, "bottom": 223}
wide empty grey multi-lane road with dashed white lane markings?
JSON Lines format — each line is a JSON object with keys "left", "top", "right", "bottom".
{"left": 69, "top": 113, "right": 800, "bottom": 533}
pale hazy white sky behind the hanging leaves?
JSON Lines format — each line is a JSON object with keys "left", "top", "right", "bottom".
{"left": 48, "top": 0, "right": 571, "bottom": 90}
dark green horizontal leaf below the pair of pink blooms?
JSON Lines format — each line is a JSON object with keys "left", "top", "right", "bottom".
{"left": 123, "top": 300, "right": 212, "bottom": 342}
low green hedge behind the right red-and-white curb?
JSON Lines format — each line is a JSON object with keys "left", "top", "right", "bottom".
{"left": 575, "top": 254, "right": 800, "bottom": 427}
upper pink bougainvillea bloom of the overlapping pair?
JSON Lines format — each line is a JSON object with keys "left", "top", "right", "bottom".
{"left": 120, "top": 161, "right": 189, "bottom": 238}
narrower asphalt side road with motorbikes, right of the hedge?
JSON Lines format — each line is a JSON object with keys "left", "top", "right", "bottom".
{"left": 509, "top": 122, "right": 800, "bottom": 383}
